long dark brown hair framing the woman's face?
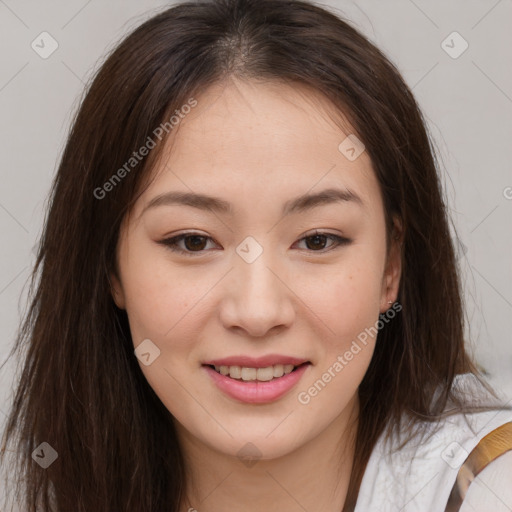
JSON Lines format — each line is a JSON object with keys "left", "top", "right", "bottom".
{"left": 2, "top": 0, "right": 498, "bottom": 512}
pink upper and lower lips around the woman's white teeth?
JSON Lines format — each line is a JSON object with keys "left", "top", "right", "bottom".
{"left": 203, "top": 356, "right": 310, "bottom": 404}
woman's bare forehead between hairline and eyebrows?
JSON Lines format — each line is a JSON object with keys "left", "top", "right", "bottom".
{"left": 134, "top": 80, "right": 380, "bottom": 217}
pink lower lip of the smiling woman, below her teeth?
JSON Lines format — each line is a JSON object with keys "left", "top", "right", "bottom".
{"left": 203, "top": 363, "right": 310, "bottom": 404}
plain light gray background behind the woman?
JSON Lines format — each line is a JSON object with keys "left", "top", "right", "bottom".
{"left": 0, "top": 0, "right": 512, "bottom": 504}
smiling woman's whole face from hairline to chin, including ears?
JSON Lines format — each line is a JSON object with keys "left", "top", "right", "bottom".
{"left": 113, "top": 82, "right": 400, "bottom": 459}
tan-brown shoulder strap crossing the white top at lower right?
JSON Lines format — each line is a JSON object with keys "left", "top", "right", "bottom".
{"left": 445, "top": 422, "right": 512, "bottom": 512}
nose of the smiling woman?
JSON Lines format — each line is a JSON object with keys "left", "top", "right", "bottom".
{"left": 221, "top": 247, "right": 295, "bottom": 337}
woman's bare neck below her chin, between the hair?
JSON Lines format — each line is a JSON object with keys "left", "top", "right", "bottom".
{"left": 176, "top": 396, "right": 358, "bottom": 512}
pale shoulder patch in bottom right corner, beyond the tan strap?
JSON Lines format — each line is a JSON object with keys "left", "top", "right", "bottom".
{"left": 460, "top": 451, "right": 512, "bottom": 512}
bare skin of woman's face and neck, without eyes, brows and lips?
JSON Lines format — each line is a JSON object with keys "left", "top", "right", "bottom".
{"left": 112, "top": 80, "right": 401, "bottom": 512}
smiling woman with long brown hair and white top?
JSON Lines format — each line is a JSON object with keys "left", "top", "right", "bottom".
{"left": 4, "top": 0, "right": 512, "bottom": 512}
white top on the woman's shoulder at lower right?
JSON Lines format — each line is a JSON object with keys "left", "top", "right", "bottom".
{"left": 354, "top": 375, "right": 512, "bottom": 512}
